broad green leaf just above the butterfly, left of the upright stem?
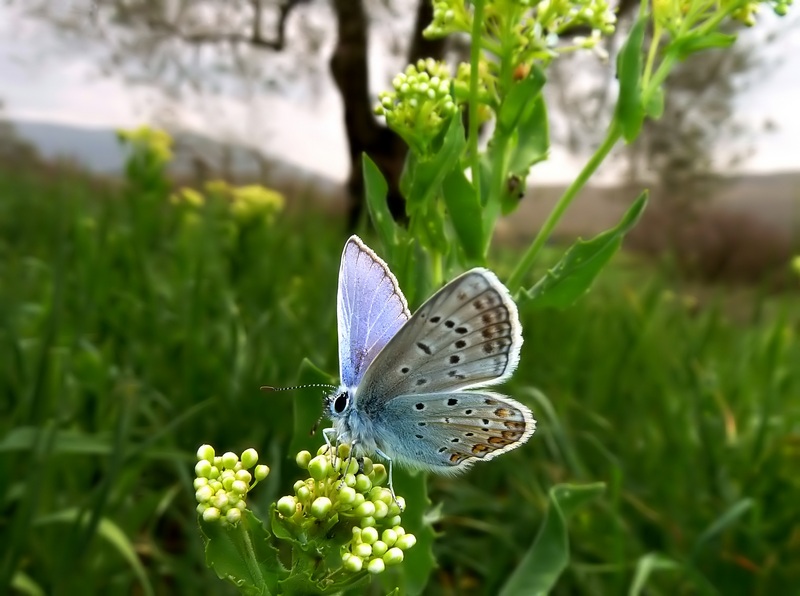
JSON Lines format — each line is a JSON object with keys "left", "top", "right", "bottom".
{"left": 442, "top": 168, "right": 483, "bottom": 261}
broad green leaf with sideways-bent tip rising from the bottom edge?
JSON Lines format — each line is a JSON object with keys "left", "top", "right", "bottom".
{"left": 500, "top": 483, "right": 605, "bottom": 596}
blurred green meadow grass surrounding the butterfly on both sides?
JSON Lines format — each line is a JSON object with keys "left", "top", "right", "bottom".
{"left": 0, "top": 159, "right": 800, "bottom": 594}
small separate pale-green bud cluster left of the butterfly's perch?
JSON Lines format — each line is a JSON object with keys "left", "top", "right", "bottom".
{"left": 194, "top": 445, "right": 269, "bottom": 524}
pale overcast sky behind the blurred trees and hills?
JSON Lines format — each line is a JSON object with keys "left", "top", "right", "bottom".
{"left": 0, "top": 5, "right": 800, "bottom": 181}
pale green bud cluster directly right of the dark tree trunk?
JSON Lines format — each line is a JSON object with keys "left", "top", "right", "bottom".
{"left": 375, "top": 58, "right": 458, "bottom": 154}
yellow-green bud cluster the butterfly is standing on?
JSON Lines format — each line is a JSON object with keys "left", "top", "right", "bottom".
{"left": 276, "top": 445, "right": 416, "bottom": 573}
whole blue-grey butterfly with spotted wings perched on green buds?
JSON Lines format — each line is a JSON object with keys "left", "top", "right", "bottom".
{"left": 325, "top": 236, "right": 536, "bottom": 492}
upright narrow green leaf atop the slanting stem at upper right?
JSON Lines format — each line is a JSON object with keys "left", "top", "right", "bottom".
{"left": 615, "top": 15, "right": 647, "bottom": 143}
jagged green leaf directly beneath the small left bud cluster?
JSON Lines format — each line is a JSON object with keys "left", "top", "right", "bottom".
{"left": 198, "top": 510, "right": 288, "bottom": 595}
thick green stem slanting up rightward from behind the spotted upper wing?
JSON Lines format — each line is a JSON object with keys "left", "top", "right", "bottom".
{"left": 508, "top": 120, "right": 622, "bottom": 294}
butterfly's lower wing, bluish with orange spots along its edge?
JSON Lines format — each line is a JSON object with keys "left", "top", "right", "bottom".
{"left": 366, "top": 391, "right": 536, "bottom": 474}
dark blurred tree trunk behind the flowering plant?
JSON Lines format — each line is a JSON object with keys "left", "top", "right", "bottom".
{"left": 330, "top": 0, "right": 444, "bottom": 229}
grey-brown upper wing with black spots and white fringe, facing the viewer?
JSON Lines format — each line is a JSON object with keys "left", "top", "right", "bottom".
{"left": 358, "top": 268, "right": 522, "bottom": 398}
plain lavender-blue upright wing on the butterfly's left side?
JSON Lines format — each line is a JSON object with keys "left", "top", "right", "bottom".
{"left": 337, "top": 236, "right": 410, "bottom": 387}
